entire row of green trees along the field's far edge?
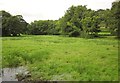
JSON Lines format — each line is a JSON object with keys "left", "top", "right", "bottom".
{"left": 0, "top": 1, "right": 120, "bottom": 38}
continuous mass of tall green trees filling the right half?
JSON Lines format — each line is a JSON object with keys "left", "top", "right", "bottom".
{"left": 55, "top": 2, "right": 120, "bottom": 38}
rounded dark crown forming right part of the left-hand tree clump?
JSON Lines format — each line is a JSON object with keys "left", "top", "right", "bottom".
{"left": 8, "top": 15, "right": 27, "bottom": 36}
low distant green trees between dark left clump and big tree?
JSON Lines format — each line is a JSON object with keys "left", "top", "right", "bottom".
{"left": 28, "top": 20, "right": 59, "bottom": 35}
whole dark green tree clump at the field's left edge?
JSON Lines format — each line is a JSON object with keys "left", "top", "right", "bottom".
{"left": 1, "top": 11, "right": 27, "bottom": 36}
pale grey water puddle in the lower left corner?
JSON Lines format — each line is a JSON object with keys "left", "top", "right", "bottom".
{"left": 0, "top": 66, "right": 28, "bottom": 82}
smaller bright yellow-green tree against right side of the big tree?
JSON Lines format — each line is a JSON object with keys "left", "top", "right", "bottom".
{"left": 81, "top": 16, "right": 100, "bottom": 37}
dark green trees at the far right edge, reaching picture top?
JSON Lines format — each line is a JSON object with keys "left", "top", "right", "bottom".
{"left": 96, "top": 1, "right": 120, "bottom": 36}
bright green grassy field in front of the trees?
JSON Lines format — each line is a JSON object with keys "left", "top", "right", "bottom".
{"left": 2, "top": 36, "right": 118, "bottom": 81}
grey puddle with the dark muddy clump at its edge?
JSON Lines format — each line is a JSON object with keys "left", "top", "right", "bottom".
{"left": 0, "top": 66, "right": 30, "bottom": 81}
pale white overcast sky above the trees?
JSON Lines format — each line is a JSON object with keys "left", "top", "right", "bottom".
{"left": 0, "top": 0, "right": 115, "bottom": 23}
